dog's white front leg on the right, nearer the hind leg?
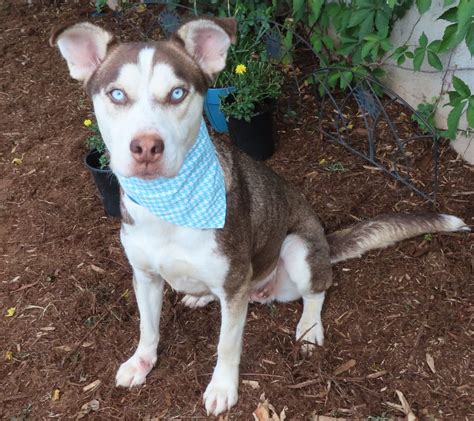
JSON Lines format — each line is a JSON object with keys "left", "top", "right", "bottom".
{"left": 204, "top": 292, "right": 248, "bottom": 415}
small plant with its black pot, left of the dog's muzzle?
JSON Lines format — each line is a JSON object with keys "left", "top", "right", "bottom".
{"left": 84, "top": 119, "right": 120, "bottom": 217}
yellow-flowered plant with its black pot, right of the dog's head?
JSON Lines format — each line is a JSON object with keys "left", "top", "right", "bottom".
{"left": 221, "top": 40, "right": 283, "bottom": 160}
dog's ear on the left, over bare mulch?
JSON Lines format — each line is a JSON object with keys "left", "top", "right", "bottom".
{"left": 49, "top": 22, "right": 113, "bottom": 83}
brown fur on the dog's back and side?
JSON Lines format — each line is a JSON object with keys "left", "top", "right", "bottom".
{"left": 216, "top": 139, "right": 332, "bottom": 296}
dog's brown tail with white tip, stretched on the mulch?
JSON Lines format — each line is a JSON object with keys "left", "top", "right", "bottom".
{"left": 327, "top": 213, "right": 470, "bottom": 263}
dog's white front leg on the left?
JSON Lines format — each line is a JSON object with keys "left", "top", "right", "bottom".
{"left": 116, "top": 270, "right": 164, "bottom": 387}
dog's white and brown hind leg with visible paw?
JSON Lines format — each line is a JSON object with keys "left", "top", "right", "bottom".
{"left": 276, "top": 230, "right": 332, "bottom": 354}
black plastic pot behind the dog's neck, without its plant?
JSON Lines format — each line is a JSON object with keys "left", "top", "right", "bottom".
{"left": 228, "top": 105, "right": 275, "bottom": 161}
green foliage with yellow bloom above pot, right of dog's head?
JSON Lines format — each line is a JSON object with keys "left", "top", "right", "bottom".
{"left": 219, "top": 38, "right": 283, "bottom": 122}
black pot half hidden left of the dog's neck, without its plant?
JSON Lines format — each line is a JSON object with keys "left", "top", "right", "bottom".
{"left": 84, "top": 150, "right": 120, "bottom": 218}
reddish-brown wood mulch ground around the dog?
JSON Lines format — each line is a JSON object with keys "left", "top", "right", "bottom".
{"left": 0, "top": 2, "right": 474, "bottom": 420}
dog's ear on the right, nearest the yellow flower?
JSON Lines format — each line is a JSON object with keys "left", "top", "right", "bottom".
{"left": 171, "top": 18, "right": 237, "bottom": 80}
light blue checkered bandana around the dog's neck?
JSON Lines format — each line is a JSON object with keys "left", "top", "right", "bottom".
{"left": 117, "top": 120, "right": 226, "bottom": 229}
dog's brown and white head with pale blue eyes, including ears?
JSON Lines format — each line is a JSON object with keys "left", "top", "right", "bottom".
{"left": 50, "top": 18, "right": 236, "bottom": 179}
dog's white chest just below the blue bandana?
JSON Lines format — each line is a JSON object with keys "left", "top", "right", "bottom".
{"left": 121, "top": 201, "right": 229, "bottom": 295}
